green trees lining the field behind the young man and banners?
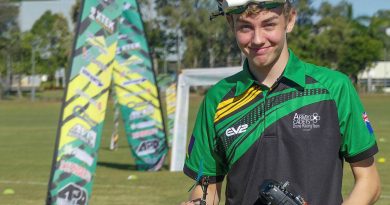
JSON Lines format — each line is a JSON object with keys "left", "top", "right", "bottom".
{"left": 0, "top": 0, "right": 390, "bottom": 83}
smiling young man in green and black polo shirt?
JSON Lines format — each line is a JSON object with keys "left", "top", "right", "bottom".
{"left": 183, "top": 0, "right": 380, "bottom": 205}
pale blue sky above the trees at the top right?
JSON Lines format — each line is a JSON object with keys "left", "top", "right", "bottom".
{"left": 313, "top": 0, "right": 390, "bottom": 17}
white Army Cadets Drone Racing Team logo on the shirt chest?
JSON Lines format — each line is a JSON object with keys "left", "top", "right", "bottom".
{"left": 293, "top": 113, "right": 321, "bottom": 131}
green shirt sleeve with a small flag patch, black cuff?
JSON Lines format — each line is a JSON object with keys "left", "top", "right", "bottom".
{"left": 338, "top": 77, "right": 378, "bottom": 163}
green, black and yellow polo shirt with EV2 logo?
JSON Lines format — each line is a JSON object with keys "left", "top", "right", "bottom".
{"left": 184, "top": 51, "right": 378, "bottom": 205}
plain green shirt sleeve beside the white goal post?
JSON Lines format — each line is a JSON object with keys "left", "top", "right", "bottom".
{"left": 183, "top": 95, "right": 226, "bottom": 183}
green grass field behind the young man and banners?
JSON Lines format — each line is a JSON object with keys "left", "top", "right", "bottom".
{"left": 0, "top": 95, "right": 390, "bottom": 205}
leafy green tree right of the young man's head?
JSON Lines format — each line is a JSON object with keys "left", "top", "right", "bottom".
{"left": 298, "top": 1, "right": 382, "bottom": 76}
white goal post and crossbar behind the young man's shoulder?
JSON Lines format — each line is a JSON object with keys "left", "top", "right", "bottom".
{"left": 170, "top": 66, "right": 242, "bottom": 171}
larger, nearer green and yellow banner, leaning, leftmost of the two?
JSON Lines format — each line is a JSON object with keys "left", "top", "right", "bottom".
{"left": 46, "top": 0, "right": 160, "bottom": 205}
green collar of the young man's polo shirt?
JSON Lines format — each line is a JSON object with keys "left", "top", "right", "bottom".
{"left": 235, "top": 49, "right": 306, "bottom": 96}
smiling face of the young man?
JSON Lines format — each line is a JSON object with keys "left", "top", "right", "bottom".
{"left": 231, "top": 7, "right": 295, "bottom": 69}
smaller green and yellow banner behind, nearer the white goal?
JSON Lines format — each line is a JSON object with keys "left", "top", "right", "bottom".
{"left": 113, "top": 0, "right": 168, "bottom": 171}
